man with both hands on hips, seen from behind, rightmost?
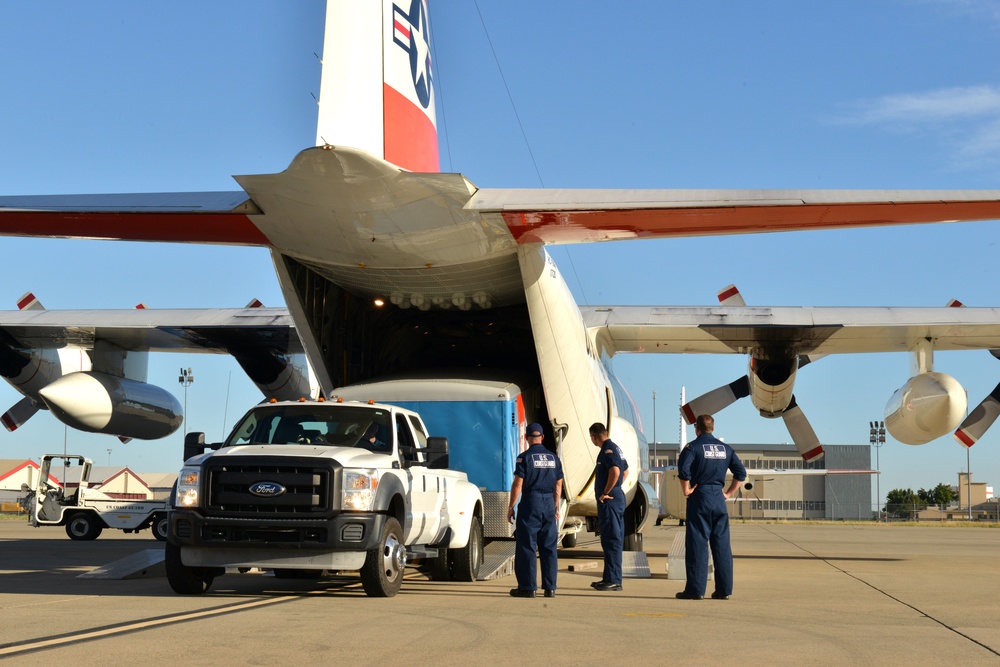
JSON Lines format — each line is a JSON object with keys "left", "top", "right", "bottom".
{"left": 677, "top": 415, "right": 747, "bottom": 600}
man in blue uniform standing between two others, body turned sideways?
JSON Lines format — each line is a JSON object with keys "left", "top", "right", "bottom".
{"left": 590, "top": 422, "right": 628, "bottom": 591}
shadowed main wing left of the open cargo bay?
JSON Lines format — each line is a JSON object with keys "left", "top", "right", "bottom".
{"left": 0, "top": 308, "right": 303, "bottom": 354}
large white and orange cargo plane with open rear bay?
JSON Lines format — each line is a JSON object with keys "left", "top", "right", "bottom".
{"left": 0, "top": 0, "right": 1000, "bottom": 544}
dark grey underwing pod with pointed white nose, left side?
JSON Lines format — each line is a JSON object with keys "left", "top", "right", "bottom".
{"left": 39, "top": 371, "right": 183, "bottom": 440}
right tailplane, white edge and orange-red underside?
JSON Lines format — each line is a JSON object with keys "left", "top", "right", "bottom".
{"left": 470, "top": 189, "right": 1000, "bottom": 244}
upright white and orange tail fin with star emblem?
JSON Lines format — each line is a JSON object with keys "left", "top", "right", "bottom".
{"left": 316, "top": 0, "right": 440, "bottom": 172}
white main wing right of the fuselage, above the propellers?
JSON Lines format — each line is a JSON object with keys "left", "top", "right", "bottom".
{"left": 581, "top": 306, "right": 1000, "bottom": 355}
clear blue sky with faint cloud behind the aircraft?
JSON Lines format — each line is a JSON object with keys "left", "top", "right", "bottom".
{"left": 0, "top": 0, "right": 1000, "bottom": 506}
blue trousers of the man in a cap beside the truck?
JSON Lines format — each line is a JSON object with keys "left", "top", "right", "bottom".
{"left": 514, "top": 492, "right": 559, "bottom": 591}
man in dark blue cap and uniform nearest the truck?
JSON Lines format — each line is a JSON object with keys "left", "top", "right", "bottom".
{"left": 507, "top": 424, "right": 562, "bottom": 598}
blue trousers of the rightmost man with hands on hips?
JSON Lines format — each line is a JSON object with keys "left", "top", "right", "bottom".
{"left": 684, "top": 485, "right": 733, "bottom": 595}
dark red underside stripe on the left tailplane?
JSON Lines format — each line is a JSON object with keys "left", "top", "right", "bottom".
{"left": 0, "top": 211, "right": 270, "bottom": 246}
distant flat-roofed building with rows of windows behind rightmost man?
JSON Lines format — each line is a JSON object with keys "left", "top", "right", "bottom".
{"left": 649, "top": 443, "right": 874, "bottom": 520}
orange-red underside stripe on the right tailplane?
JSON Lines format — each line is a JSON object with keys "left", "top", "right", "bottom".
{"left": 502, "top": 201, "right": 1000, "bottom": 243}
